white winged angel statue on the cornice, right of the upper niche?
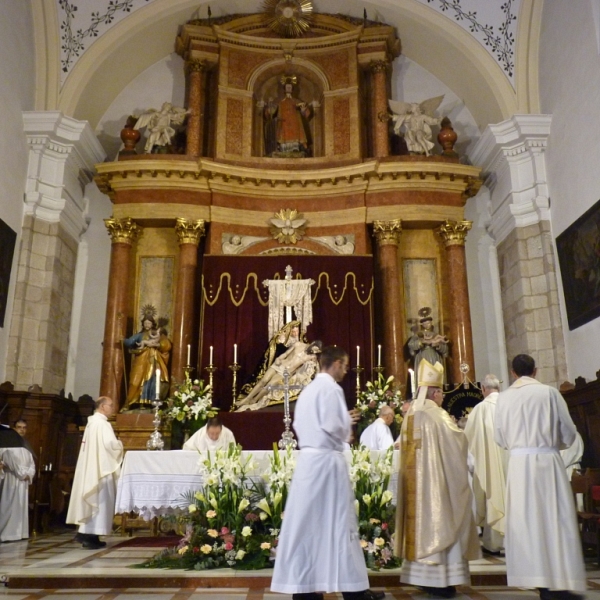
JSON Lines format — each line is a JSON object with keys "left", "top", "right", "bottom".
{"left": 388, "top": 96, "right": 444, "bottom": 156}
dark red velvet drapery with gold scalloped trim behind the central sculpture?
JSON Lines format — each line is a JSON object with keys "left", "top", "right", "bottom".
{"left": 198, "top": 255, "right": 374, "bottom": 409}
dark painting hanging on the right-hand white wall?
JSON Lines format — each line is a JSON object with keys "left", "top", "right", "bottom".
{"left": 556, "top": 201, "right": 600, "bottom": 330}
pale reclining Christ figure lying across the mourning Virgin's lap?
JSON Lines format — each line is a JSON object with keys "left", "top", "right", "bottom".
{"left": 236, "top": 332, "right": 322, "bottom": 412}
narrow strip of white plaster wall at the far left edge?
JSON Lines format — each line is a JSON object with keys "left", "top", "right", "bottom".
{"left": 0, "top": 1, "right": 35, "bottom": 382}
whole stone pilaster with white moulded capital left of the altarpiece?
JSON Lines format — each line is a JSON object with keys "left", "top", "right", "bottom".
{"left": 6, "top": 112, "right": 105, "bottom": 393}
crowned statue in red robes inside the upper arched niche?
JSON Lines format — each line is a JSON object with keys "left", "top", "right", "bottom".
{"left": 263, "top": 75, "right": 313, "bottom": 158}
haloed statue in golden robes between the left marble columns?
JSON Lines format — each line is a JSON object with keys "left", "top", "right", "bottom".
{"left": 123, "top": 306, "right": 172, "bottom": 410}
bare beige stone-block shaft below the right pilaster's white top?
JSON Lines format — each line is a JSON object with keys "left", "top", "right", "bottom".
{"left": 498, "top": 221, "right": 567, "bottom": 386}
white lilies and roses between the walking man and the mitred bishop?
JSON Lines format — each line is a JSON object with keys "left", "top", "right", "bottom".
{"left": 350, "top": 446, "right": 400, "bottom": 571}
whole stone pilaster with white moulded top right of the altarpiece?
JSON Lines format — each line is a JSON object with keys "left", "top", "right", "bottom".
{"left": 470, "top": 115, "right": 567, "bottom": 386}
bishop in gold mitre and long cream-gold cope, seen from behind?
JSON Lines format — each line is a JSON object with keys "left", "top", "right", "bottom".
{"left": 396, "top": 359, "right": 481, "bottom": 598}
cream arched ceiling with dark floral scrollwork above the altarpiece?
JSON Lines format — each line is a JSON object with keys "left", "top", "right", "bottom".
{"left": 32, "top": 0, "right": 543, "bottom": 129}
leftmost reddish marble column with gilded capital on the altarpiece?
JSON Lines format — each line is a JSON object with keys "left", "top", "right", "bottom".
{"left": 100, "top": 218, "right": 141, "bottom": 406}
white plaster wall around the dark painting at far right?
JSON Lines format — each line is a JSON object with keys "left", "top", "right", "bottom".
{"left": 539, "top": 0, "right": 600, "bottom": 381}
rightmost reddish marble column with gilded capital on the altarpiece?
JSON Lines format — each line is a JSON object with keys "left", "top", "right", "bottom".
{"left": 437, "top": 221, "right": 477, "bottom": 383}
